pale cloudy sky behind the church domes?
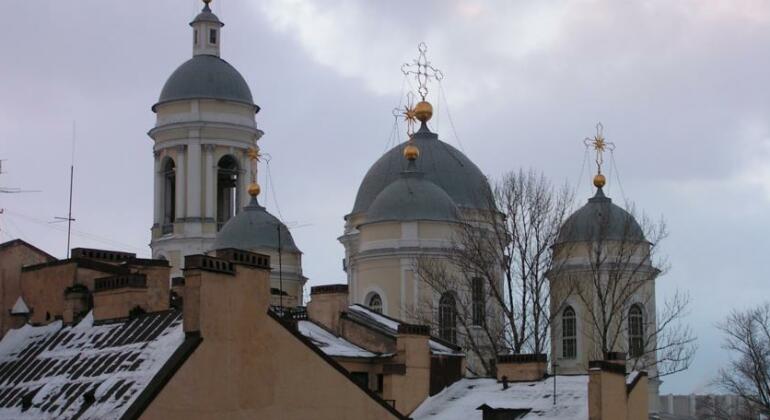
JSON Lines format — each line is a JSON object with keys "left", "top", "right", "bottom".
{"left": 0, "top": 0, "right": 770, "bottom": 393}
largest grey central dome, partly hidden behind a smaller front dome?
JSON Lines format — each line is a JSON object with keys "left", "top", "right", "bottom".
{"left": 351, "top": 125, "right": 490, "bottom": 214}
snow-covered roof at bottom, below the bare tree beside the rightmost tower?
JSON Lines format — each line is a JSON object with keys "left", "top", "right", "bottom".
{"left": 411, "top": 375, "right": 588, "bottom": 420}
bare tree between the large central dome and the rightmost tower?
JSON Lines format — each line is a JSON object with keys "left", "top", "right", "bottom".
{"left": 416, "top": 170, "right": 571, "bottom": 374}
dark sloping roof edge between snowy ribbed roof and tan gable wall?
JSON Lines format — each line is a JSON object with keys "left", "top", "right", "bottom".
{"left": 120, "top": 333, "right": 203, "bottom": 420}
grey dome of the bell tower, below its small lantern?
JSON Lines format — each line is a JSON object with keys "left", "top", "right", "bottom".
{"left": 152, "top": 54, "right": 259, "bottom": 112}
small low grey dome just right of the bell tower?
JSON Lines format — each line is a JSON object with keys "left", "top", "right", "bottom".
{"left": 212, "top": 198, "right": 300, "bottom": 252}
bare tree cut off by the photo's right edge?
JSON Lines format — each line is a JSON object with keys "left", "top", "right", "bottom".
{"left": 714, "top": 303, "right": 770, "bottom": 418}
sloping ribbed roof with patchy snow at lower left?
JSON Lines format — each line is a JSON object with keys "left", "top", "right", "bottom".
{"left": 0, "top": 311, "right": 185, "bottom": 419}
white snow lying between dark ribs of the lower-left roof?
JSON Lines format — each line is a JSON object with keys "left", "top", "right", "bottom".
{"left": 0, "top": 313, "right": 185, "bottom": 419}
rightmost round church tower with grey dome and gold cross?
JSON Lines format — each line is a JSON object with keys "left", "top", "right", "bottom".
{"left": 548, "top": 124, "right": 661, "bottom": 412}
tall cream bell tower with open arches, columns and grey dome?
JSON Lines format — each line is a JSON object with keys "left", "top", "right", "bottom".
{"left": 148, "top": 0, "right": 263, "bottom": 276}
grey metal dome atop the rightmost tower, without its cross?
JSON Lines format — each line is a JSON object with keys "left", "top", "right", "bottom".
{"left": 556, "top": 188, "right": 646, "bottom": 244}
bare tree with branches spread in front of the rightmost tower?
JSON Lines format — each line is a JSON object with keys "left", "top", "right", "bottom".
{"left": 551, "top": 195, "right": 697, "bottom": 378}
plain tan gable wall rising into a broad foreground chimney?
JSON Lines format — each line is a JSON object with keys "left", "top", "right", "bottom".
{"left": 142, "top": 265, "right": 396, "bottom": 420}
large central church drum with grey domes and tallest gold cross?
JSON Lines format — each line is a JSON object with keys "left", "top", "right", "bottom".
{"left": 339, "top": 44, "right": 496, "bottom": 360}
